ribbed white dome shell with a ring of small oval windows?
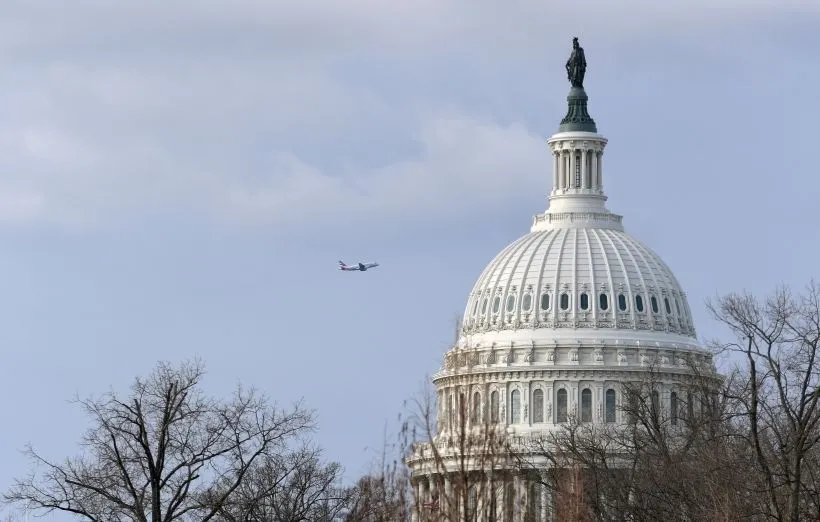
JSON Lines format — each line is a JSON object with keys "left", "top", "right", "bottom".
{"left": 462, "top": 227, "right": 697, "bottom": 344}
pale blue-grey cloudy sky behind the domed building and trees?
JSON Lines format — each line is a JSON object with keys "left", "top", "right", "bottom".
{"left": 0, "top": 0, "right": 820, "bottom": 520}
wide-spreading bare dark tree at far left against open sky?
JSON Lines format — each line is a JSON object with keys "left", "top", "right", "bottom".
{"left": 3, "top": 361, "right": 313, "bottom": 522}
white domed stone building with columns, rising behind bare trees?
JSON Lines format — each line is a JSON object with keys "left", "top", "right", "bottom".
{"left": 408, "top": 38, "right": 714, "bottom": 521}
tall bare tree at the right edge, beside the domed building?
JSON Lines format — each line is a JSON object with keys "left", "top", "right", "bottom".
{"left": 708, "top": 281, "right": 820, "bottom": 522}
